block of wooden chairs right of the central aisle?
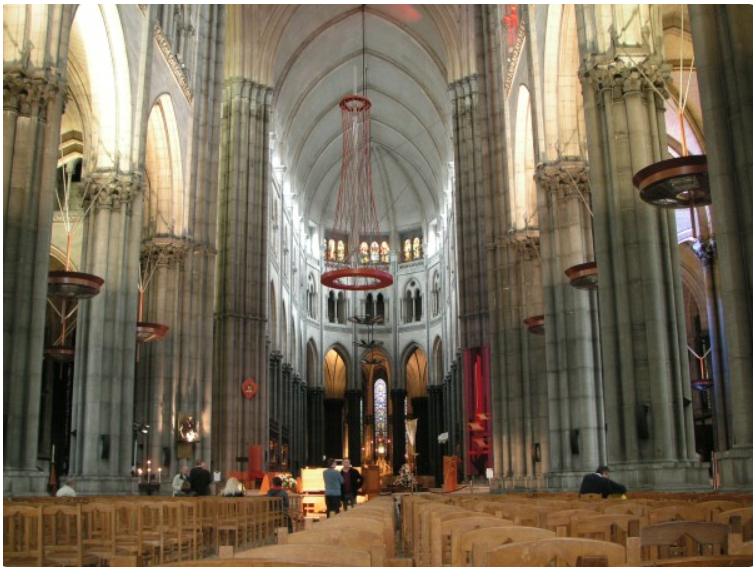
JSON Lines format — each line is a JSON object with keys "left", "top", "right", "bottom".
{"left": 402, "top": 494, "right": 753, "bottom": 566}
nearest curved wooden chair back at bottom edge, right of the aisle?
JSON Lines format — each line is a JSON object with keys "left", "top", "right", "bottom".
{"left": 473, "top": 538, "right": 626, "bottom": 567}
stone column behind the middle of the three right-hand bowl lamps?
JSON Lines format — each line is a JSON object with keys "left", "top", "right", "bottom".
{"left": 535, "top": 161, "right": 606, "bottom": 478}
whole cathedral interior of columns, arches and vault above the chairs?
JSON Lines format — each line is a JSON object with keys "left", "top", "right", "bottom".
{"left": 3, "top": 4, "right": 753, "bottom": 496}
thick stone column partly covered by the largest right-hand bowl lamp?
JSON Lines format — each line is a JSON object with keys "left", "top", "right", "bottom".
{"left": 575, "top": 5, "right": 707, "bottom": 489}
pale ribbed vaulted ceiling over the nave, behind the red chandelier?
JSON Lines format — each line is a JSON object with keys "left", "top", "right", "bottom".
{"left": 226, "top": 5, "right": 464, "bottom": 231}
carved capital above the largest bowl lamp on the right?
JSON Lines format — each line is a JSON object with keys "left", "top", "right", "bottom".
{"left": 580, "top": 55, "right": 672, "bottom": 100}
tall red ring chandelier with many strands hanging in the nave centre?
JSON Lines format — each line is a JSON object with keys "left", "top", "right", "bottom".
{"left": 320, "top": 6, "right": 394, "bottom": 290}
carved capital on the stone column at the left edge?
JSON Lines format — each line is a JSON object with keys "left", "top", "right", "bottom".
{"left": 3, "top": 68, "right": 65, "bottom": 122}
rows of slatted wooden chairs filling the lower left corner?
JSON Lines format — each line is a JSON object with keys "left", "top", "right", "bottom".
{"left": 3, "top": 497, "right": 284, "bottom": 566}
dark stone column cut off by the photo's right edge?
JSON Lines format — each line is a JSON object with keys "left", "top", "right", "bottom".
{"left": 690, "top": 4, "right": 753, "bottom": 490}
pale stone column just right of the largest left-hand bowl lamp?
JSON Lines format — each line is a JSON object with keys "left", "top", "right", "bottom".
{"left": 70, "top": 172, "right": 145, "bottom": 492}
